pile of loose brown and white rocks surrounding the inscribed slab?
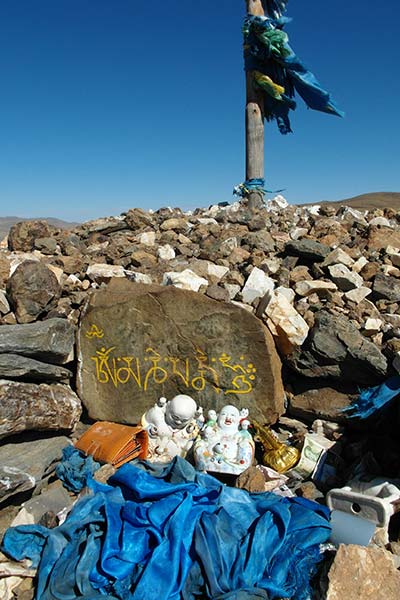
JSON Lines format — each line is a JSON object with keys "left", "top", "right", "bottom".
{"left": 0, "top": 202, "right": 400, "bottom": 598}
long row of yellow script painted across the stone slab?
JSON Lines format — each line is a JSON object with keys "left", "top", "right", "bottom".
{"left": 91, "top": 346, "right": 257, "bottom": 395}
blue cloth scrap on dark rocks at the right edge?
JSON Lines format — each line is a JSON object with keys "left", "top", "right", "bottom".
{"left": 343, "top": 375, "right": 400, "bottom": 419}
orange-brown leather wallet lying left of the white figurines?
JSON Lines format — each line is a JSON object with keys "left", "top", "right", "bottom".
{"left": 75, "top": 421, "right": 148, "bottom": 468}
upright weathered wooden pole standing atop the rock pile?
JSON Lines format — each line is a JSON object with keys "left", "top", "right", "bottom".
{"left": 246, "top": 0, "right": 265, "bottom": 208}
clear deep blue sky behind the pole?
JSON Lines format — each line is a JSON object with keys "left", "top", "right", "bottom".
{"left": 0, "top": 0, "right": 400, "bottom": 221}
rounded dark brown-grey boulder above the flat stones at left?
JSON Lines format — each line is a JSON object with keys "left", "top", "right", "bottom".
{"left": 7, "top": 261, "right": 61, "bottom": 323}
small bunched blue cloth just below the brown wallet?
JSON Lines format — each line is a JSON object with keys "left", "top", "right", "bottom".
{"left": 56, "top": 446, "right": 100, "bottom": 493}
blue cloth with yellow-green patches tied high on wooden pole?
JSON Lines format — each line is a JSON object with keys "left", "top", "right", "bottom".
{"left": 243, "top": 12, "right": 344, "bottom": 134}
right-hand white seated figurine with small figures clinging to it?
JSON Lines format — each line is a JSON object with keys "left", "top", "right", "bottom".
{"left": 193, "top": 404, "right": 254, "bottom": 475}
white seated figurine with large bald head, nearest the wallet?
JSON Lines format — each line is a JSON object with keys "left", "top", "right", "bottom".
{"left": 141, "top": 394, "right": 204, "bottom": 463}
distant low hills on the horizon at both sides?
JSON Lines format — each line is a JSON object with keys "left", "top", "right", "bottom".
{"left": 0, "top": 192, "right": 400, "bottom": 240}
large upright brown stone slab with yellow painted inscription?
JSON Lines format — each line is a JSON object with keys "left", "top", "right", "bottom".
{"left": 77, "top": 280, "right": 284, "bottom": 423}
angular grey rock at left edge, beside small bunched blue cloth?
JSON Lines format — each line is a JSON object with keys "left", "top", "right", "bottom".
{"left": 0, "top": 436, "right": 71, "bottom": 503}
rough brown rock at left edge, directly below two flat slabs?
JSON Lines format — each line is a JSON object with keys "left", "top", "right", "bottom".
{"left": 0, "top": 379, "right": 82, "bottom": 440}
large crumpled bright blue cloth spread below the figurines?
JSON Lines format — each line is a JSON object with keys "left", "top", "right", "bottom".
{"left": 2, "top": 458, "right": 331, "bottom": 600}
